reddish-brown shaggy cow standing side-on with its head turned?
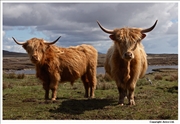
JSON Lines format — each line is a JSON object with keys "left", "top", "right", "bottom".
{"left": 13, "top": 37, "right": 97, "bottom": 100}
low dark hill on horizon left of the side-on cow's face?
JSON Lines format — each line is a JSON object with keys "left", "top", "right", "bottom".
{"left": 3, "top": 50, "right": 28, "bottom": 57}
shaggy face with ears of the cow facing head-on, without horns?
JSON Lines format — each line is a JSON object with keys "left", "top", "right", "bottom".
{"left": 109, "top": 28, "right": 146, "bottom": 61}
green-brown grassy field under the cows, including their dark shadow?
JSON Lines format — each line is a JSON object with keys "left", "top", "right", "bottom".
{"left": 2, "top": 70, "right": 178, "bottom": 120}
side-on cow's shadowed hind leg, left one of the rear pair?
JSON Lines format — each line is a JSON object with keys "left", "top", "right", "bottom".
{"left": 81, "top": 75, "right": 89, "bottom": 98}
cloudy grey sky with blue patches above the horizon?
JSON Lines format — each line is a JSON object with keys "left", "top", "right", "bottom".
{"left": 1, "top": 2, "right": 178, "bottom": 53}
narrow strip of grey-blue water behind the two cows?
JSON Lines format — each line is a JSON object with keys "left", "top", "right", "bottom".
{"left": 6, "top": 65, "right": 178, "bottom": 74}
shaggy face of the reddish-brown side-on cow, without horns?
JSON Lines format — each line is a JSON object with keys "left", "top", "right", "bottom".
{"left": 23, "top": 38, "right": 47, "bottom": 64}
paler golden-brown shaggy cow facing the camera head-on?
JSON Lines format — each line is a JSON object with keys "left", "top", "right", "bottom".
{"left": 97, "top": 21, "right": 157, "bottom": 105}
